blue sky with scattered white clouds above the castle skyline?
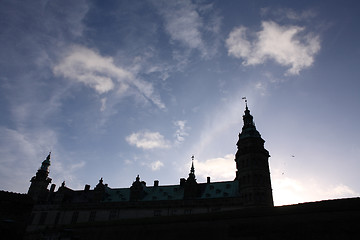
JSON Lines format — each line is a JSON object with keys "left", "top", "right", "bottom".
{"left": 0, "top": 0, "right": 360, "bottom": 205}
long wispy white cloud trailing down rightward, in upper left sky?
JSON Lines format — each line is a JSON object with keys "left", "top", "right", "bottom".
{"left": 53, "top": 46, "right": 165, "bottom": 109}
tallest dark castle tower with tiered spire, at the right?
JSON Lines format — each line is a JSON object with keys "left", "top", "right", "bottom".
{"left": 235, "top": 101, "right": 274, "bottom": 206}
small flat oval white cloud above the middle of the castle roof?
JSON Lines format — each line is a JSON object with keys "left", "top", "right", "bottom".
{"left": 126, "top": 131, "right": 170, "bottom": 150}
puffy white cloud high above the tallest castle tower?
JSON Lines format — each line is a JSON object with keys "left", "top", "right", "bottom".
{"left": 226, "top": 21, "right": 320, "bottom": 75}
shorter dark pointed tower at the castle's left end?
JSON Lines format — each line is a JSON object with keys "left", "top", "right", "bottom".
{"left": 28, "top": 153, "right": 51, "bottom": 201}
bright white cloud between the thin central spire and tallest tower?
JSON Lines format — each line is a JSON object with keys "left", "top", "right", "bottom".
{"left": 194, "top": 154, "right": 236, "bottom": 181}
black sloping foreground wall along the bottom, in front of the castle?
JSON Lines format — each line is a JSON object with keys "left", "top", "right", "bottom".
{"left": 26, "top": 198, "right": 360, "bottom": 240}
